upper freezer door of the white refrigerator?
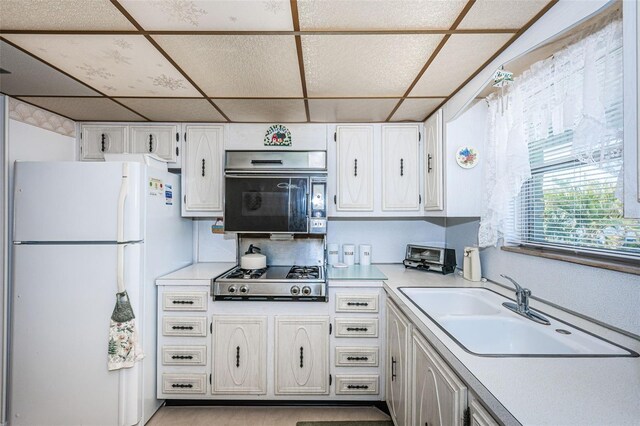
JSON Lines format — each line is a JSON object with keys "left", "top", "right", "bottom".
{"left": 13, "top": 162, "right": 146, "bottom": 242}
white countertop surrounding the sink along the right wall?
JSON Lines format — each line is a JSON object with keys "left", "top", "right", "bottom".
{"left": 376, "top": 264, "right": 640, "bottom": 425}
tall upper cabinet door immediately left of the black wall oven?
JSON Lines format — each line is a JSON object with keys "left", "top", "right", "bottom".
{"left": 183, "top": 126, "right": 224, "bottom": 215}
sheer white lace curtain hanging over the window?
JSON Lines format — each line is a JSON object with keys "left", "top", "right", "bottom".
{"left": 478, "top": 10, "right": 622, "bottom": 247}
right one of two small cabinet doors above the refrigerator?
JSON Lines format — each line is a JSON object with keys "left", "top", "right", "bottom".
{"left": 129, "top": 126, "right": 180, "bottom": 162}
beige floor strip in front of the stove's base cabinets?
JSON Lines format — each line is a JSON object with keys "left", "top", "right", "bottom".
{"left": 147, "top": 406, "right": 389, "bottom": 426}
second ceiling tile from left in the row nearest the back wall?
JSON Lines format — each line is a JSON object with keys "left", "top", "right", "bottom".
{"left": 116, "top": 98, "right": 227, "bottom": 122}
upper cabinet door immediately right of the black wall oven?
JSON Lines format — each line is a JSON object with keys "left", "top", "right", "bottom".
{"left": 336, "top": 126, "right": 373, "bottom": 211}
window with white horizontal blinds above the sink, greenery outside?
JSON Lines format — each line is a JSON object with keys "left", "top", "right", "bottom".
{"left": 505, "top": 11, "right": 640, "bottom": 258}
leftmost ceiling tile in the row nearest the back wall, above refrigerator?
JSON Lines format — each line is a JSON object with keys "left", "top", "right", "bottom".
{"left": 18, "top": 97, "right": 144, "bottom": 121}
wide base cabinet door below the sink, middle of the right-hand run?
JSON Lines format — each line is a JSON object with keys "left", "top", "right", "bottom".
{"left": 411, "top": 331, "right": 467, "bottom": 426}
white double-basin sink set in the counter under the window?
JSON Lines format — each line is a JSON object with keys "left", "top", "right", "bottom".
{"left": 400, "top": 287, "right": 638, "bottom": 357}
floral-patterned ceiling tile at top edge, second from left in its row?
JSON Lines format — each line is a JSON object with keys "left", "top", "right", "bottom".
{"left": 120, "top": 0, "right": 293, "bottom": 31}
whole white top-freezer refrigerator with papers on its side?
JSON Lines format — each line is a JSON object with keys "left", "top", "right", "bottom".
{"left": 8, "top": 157, "right": 193, "bottom": 426}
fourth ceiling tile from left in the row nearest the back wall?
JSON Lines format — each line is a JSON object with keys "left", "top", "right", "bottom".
{"left": 309, "top": 99, "right": 399, "bottom": 123}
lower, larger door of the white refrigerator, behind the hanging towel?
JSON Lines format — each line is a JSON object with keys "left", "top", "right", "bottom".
{"left": 9, "top": 244, "right": 142, "bottom": 426}
